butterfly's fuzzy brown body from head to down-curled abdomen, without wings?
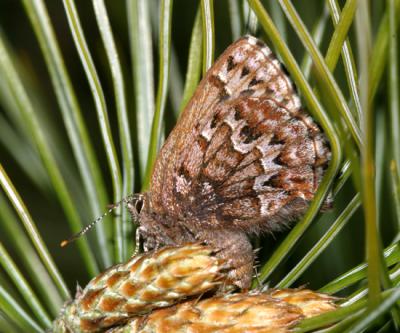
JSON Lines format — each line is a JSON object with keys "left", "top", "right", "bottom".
{"left": 127, "top": 193, "right": 254, "bottom": 289}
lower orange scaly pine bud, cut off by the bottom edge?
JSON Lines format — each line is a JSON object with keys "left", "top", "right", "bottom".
{"left": 107, "top": 293, "right": 304, "bottom": 333}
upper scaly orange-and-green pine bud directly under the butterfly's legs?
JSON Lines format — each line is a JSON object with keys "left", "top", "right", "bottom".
{"left": 54, "top": 244, "right": 226, "bottom": 333}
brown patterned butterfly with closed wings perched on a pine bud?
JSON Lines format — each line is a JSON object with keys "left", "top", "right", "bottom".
{"left": 127, "top": 36, "right": 330, "bottom": 289}
